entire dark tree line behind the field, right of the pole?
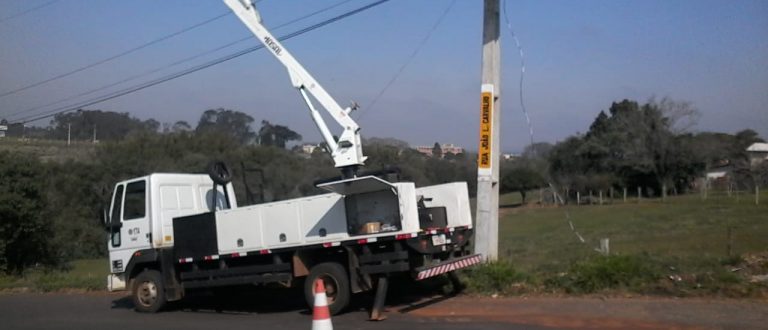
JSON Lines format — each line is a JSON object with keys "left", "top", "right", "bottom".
{"left": 501, "top": 98, "right": 768, "bottom": 202}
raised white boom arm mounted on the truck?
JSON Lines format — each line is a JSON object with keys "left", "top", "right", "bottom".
{"left": 223, "top": 0, "right": 367, "bottom": 177}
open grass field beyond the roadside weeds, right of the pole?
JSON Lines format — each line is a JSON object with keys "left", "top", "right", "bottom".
{"left": 499, "top": 194, "right": 768, "bottom": 271}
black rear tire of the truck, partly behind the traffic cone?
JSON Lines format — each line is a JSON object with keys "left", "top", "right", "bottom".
{"left": 304, "top": 262, "right": 351, "bottom": 315}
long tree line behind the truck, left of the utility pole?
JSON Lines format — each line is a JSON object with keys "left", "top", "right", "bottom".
{"left": 0, "top": 109, "right": 475, "bottom": 274}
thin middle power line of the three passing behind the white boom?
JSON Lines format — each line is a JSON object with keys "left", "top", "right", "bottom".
{"left": 6, "top": 0, "right": 352, "bottom": 117}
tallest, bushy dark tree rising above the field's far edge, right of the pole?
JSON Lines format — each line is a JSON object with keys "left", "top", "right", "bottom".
{"left": 550, "top": 98, "right": 701, "bottom": 196}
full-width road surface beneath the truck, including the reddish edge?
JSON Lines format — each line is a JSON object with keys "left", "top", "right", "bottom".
{"left": 0, "top": 290, "right": 768, "bottom": 330}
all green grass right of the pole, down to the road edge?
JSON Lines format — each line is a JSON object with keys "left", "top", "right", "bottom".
{"left": 464, "top": 191, "right": 768, "bottom": 297}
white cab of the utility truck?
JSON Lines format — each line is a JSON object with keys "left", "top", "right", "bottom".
{"left": 104, "top": 173, "right": 237, "bottom": 291}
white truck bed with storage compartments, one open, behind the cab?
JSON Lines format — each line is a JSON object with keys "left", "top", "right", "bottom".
{"left": 173, "top": 182, "right": 471, "bottom": 262}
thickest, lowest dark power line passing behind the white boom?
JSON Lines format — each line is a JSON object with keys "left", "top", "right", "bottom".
{"left": 14, "top": 0, "right": 389, "bottom": 124}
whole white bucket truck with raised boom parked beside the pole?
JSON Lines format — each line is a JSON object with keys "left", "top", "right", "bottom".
{"left": 103, "top": 0, "right": 481, "bottom": 319}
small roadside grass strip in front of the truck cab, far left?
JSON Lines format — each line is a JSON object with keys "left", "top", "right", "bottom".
{"left": 0, "top": 259, "right": 109, "bottom": 292}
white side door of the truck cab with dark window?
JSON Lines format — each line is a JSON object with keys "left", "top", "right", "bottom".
{"left": 109, "top": 179, "right": 151, "bottom": 273}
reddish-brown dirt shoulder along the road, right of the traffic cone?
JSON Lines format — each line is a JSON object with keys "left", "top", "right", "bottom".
{"left": 399, "top": 296, "right": 768, "bottom": 329}
